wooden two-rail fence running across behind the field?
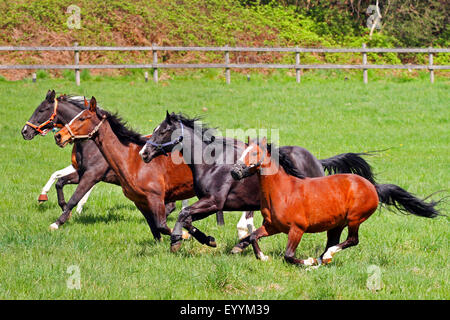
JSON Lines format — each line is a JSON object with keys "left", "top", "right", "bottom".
{"left": 0, "top": 43, "right": 450, "bottom": 85}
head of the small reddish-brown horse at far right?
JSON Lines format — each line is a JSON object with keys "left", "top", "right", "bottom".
{"left": 231, "top": 137, "right": 270, "bottom": 180}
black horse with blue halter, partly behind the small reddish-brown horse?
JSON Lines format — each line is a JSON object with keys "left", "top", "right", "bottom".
{"left": 141, "top": 112, "right": 374, "bottom": 252}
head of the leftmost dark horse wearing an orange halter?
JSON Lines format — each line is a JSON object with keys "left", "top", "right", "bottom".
{"left": 22, "top": 90, "right": 58, "bottom": 140}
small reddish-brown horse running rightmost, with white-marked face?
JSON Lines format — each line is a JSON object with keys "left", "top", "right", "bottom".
{"left": 230, "top": 138, "right": 440, "bottom": 266}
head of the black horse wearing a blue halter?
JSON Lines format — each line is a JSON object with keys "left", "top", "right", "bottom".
{"left": 139, "top": 111, "right": 184, "bottom": 163}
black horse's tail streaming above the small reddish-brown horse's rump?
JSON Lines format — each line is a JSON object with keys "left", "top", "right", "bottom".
{"left": 319, "top": 152, "right": 376, "bottom": 184}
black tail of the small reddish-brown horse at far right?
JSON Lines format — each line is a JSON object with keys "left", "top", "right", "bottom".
{"left": 375, "top": 184, "right": 441, "bottom": 218}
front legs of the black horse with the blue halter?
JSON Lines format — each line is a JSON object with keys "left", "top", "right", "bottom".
{"left": 170, "top": 197, "right": 221, "bottom": 252}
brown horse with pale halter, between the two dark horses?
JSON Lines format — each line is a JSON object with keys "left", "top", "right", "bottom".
{"left": 55, "top": 97, "right": 195, "bottom": 240}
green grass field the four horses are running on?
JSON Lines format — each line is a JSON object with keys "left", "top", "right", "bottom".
{"left": 0, "top": 76, "right": 450, "bottom": 299}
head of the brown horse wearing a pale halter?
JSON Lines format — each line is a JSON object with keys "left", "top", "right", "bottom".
{"left": 55, "top": 97, "right": 106, "bottom": 148}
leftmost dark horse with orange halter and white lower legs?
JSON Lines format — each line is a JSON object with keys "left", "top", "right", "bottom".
{"left": 21, "top": 90, "right": 193, "bottom": 230}
